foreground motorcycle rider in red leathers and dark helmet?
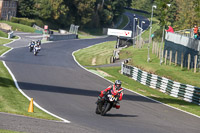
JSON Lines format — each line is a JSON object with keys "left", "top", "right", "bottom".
{"left": 98, "top": 80, "right": 124, "bottom": 109}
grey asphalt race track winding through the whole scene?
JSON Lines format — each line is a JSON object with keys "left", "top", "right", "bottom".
{"left": 0, "top": 12, "right": 200, "bottom": 133}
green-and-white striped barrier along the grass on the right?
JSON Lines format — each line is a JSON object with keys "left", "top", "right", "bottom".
{"left": 121, "top": 62, "right": 200, "bottom": 105}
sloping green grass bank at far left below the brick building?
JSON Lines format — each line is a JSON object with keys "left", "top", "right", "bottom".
{"left": 0, "top": 20, "right": 35, "bottom": 33}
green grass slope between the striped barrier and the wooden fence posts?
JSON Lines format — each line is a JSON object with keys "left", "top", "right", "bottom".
{"left": 120, "top": 44, "right": 200, "bottom": 87}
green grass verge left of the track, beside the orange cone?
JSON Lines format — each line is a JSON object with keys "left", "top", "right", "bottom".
{"left": 0, "top": 39, "right": 59, "bottom": 120}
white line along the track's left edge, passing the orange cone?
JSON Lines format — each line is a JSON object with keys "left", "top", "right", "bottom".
{"left": 1, "top": 38, "right": 71, "bottom": 123}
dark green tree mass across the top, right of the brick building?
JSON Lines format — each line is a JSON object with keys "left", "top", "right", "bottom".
{"left": 18, "top": 0, "right": 131, "bottom": 28}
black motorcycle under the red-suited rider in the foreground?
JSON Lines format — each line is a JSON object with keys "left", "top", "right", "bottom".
{"left": 96, "top": 90, "right": 118, "bottom": 116}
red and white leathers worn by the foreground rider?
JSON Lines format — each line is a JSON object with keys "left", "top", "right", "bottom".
{"left": 99, "top": 84, "right": 124, "bottom": 109}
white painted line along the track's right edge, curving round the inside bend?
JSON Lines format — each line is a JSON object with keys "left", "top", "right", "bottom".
{"left": 72, "top": 43, "right": 200, "bottom": 118}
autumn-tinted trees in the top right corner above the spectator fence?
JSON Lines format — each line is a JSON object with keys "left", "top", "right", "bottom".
{"left": 131, "top": 0, "right": 200, "bottom": 30}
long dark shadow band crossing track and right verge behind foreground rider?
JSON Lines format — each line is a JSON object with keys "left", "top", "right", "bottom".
{"left": 14, "top": 82, "right": 198, "bottom": 106}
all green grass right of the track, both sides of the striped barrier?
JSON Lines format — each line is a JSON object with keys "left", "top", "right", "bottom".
{"left": 75, "top": 41, "right": 200, "bottom": 116}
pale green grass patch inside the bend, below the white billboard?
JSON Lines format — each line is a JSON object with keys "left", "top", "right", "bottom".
{"left": 75, "top": 41, "right": 116, "bottom": 66}
